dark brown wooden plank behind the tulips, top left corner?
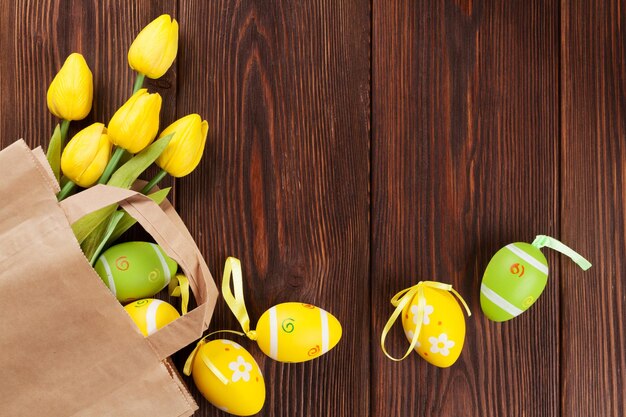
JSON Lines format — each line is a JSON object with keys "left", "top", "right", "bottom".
{"left": 0, "top": 0, "right": 176, "bottom": 147}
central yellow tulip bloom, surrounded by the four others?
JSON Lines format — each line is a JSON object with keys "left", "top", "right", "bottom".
{"left": 108, "top": 88, "right": 161, "bottom": 153}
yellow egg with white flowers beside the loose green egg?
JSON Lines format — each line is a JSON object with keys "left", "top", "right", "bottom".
{"left": 402, "top": 287, "right": 465, "bottom": 368}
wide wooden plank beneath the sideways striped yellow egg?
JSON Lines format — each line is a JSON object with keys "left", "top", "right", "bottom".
{"left": 176, "top": 0, "right": 370, "bottom": 416}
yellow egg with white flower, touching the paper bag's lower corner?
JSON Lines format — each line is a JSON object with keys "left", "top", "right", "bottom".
{"left": 191, "top": 339, "right": 265, "bottom": 416}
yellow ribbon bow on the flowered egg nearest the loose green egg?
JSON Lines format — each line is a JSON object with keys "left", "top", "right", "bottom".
{"left": 380, "top": 281, "right": 472, "bottom": 362}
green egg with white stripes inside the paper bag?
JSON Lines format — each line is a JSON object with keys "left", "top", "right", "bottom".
{"left": 94, "top": 242, "right": 178, "bottom": 303}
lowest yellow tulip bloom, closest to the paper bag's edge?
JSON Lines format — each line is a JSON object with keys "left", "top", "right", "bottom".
{"left": 61, "top": 123, "right": 111, "bottom": 187}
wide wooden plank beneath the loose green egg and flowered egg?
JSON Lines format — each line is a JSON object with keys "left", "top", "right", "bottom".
{"left": 371, "top": 0, "right": 560, "bottom": 417}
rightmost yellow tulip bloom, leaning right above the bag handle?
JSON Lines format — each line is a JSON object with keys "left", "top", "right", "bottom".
{"left": 156, "top": 114, "right": 209, "bottom": 178}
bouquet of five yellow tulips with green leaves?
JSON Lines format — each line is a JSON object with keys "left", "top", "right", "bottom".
{"left": 47, "top": 15, "right": 209, "bottom": 265}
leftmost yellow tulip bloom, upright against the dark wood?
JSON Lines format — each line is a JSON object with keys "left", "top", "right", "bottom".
{"left": 47, "top": 53, "right": 93, "bottom": 120}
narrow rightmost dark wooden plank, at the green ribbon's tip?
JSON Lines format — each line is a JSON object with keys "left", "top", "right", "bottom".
{"left": 560, "top": 0, "right": 626, "bottom": 417}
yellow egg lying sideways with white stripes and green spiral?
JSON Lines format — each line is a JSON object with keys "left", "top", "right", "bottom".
{"left": 256, "top": 303, "right": 341, "bottom": 362}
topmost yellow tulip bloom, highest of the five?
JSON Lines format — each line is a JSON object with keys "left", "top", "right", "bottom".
{"left": 128, "top": 14, "right": 178, "bottom": 78}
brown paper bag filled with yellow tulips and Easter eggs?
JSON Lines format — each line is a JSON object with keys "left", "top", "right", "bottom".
{"left": 0, "top": 15, "right": 218, "bottom": 417}
